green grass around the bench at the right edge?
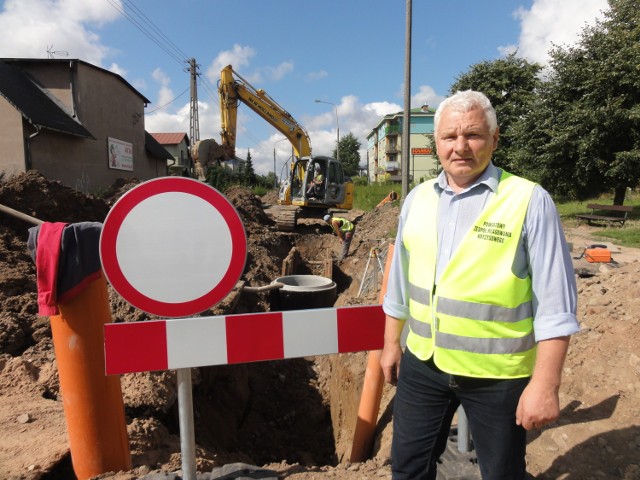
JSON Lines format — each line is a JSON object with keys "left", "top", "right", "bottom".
{"left": 556, "top": 191, "right": 640, "bottom": 248}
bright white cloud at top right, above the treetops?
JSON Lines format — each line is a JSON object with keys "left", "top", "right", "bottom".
{"left": 499, "top": 0, "right": 608, "bottom": 64}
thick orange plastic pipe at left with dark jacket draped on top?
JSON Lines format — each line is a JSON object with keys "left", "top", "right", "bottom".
{"left": 50, "top": 274, "right": 131, "bottom": 480}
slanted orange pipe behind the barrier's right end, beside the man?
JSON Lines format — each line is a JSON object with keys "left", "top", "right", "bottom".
{"left": 349, "top": 243, "right": 394, "bottom": 462}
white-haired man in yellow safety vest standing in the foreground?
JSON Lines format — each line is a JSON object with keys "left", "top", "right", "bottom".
{"left": 380, "top": 90, "right": 579, "bottom": 480}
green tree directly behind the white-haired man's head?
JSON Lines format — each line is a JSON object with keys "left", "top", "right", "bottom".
{"left": 449, "top": 53, "right": 542, "bottom": 173}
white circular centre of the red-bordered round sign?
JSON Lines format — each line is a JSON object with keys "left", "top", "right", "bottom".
{"left": 116, "top": 192, "right": 233, "bottom": 303}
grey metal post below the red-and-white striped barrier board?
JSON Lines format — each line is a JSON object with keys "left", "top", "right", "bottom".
{"left": 176, "top": 368, "right": 196, "bottom": 480}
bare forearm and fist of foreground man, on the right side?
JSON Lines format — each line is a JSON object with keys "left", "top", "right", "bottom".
{"left": 516, "top": 337, "right": 569, "bottom": 430}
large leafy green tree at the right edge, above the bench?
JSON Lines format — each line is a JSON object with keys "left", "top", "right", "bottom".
{"left": 515, "top": 0, "right": 640, "bottom": 205}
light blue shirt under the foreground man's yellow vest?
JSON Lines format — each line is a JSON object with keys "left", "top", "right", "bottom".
{"left": 382, "top": 163, "right": 580, "bottom": 341}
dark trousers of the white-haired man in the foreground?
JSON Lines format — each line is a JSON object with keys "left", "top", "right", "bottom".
{"left": 391, "top": 349, "right": 529, "bottom": 480}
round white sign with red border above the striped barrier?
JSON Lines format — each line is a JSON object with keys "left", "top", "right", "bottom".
{"left": 100, "top": 177, "right": 247, "bottom": 317}
